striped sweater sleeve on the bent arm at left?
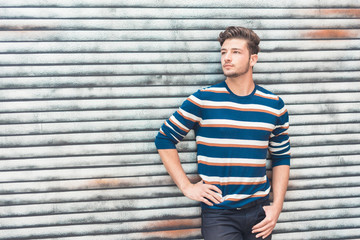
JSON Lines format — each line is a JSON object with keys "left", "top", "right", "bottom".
{"left": 155, "top": 90, "right": 201, "bottom": 149}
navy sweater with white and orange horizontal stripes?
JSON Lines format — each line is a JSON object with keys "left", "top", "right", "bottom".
{"left": 155, "top": 81, "right": 290, "bottom": 209}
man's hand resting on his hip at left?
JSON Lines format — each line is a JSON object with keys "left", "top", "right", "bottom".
{"left": 183, "top": 181, "right": 223, "bottom": 206}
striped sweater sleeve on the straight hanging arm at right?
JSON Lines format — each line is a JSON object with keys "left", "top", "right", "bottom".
{"left": 269, "top": 99, "right": 290, "bottom": 167}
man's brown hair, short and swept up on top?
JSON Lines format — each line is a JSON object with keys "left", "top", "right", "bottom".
{"left": 218, "top": 26, "right": 260, "bottom": 55}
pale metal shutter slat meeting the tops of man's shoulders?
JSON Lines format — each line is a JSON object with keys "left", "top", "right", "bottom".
{"left": 0, "top": 81, "right": 360, "bottom": 102}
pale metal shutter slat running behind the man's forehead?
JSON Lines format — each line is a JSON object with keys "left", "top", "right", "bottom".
{"left": 0, "top": 39, "right": 360, "bottom": 53}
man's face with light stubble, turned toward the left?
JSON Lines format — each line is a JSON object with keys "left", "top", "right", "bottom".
{"left": 221, "top": 38, "right": 257, "bottom": 78}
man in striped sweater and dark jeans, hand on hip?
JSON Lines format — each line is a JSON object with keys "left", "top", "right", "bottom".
{"left": 155, "top": 27, "right": 290, "bottom": 240}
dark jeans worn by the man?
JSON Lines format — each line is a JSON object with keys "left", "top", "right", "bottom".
{"left": 201, "top": 200, "right": 271, "bottom": 240}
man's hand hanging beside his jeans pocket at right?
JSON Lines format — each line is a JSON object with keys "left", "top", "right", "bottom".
{"left": 252, "top": 206, "right": 281, "bottom": 239}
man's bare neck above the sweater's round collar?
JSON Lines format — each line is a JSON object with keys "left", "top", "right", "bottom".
{"left": 225, "top": 77, "right": 255, "bottom": 96}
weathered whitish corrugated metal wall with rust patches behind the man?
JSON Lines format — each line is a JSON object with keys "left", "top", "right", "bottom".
{"left": 0, "top": 0, "right": 360, "bottom": 240}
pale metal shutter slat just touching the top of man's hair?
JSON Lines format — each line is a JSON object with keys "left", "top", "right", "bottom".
{"left": 0, "top": 19, "right": 358, "bottom": 31}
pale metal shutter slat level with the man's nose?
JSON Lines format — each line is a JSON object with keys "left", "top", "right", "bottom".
{"left": 0, "top": 50, "right": 360, "bottom": 65}
